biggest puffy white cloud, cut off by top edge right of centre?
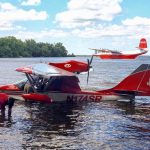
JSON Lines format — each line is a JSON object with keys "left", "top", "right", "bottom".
{"left": 55, "top": 0, "right": 122, "bottom": 28}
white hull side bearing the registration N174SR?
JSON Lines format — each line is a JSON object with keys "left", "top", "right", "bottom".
{"left": 48, "top": 93, "right": 123, "bottom": 102}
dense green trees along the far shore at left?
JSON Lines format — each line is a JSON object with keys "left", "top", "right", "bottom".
{"left": 0, "top": 36, "right": 74, "bottom": 57}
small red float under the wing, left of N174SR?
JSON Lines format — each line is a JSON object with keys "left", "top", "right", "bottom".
{"left": 22, "top": 93, "right": 52, "bottom": 103}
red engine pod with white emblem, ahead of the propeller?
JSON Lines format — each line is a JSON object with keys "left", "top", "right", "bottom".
{"left": 49, "top": 60, "right": 89, "bottom": 73}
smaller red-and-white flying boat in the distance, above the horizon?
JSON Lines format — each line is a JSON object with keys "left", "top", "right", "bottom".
{"left": 92, "top": 38, "right": 148, "bottom": 59}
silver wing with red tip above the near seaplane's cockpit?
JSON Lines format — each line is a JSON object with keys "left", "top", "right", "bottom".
{"left": 16, "top": 63, "right": 75, "bottom": 77}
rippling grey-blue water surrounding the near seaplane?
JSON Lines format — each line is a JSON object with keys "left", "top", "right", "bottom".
{"left": 0, "top": 56, "right": 150, "bottom": 150}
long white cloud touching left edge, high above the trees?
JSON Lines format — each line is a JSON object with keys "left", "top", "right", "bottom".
{"left": 0, "top": 3, "right": 48, "bottom": 22}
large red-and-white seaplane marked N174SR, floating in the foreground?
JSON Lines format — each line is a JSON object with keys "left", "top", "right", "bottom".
{"left": 0, "top": 61, "right": 150, "bottom": 103}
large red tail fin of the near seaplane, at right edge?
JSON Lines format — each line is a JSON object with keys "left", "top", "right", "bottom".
{"left": 113, "top": 64, "right": 150, "bottom": 96}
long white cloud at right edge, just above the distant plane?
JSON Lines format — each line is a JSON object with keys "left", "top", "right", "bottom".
{"left": 72, "top": 24, "right": 150, "bottom": 38}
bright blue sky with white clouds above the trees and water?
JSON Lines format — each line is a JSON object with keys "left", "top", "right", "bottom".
{"left": 0, "top": 0, "right": 150, "bottom": 55}
